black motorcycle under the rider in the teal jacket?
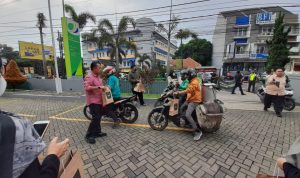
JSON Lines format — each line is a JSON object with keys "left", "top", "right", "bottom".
{"left": 83, "top": 95, "right": 139, "bottom": 123}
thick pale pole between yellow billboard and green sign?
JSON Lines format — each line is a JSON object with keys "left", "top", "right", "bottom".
{"left": 48, "top": 0, "right": 62, "bottom": 93}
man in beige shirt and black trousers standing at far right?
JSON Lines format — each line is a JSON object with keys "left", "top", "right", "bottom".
{"left": 264, "top": 68, "right": 286, "bottom": 117}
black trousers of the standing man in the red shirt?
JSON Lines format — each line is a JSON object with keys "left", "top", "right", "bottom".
{"left": 86, "top": 104, "right": 103, "bottom": 138}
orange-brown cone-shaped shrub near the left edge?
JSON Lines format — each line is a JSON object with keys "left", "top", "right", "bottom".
{"left": 4, "top": 60, "right": 27, "bottom": 89}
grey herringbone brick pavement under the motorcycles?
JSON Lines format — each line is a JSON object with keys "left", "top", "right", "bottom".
{"left": 0, "top": 91, "right": 300, "bottom": 178}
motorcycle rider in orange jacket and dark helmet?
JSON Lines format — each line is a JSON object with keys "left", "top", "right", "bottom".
{"left": 175, "top": 69, "right": 202, "bottom": 141}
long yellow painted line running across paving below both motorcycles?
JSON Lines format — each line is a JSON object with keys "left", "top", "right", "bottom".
{"left": 49, "top": 116, "right": 192, "bottom": 132}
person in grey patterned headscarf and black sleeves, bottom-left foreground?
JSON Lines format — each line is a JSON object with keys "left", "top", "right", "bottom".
{"left": 0, "top": 111, "right": 69, "bottom": 178}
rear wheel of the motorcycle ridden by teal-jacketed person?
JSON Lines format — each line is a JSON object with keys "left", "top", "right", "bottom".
{"left": 120, "top": 103, "right": 139, "bottom": 124}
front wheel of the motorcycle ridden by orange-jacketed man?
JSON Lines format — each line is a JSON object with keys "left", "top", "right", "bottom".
{"left": 148, "top": 108, "right": 168, "bottom": 131}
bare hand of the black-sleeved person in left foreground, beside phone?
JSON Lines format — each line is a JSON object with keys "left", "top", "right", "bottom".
{"left": 48, "top": 137, "right": 69, "bottom": 158}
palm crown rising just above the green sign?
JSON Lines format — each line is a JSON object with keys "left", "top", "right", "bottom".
{"left": 65, "top": 4, "right": 96, "bottom": 29}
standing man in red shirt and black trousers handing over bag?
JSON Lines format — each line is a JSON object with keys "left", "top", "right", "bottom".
{"left": 84, "top": 61, "right": 107, "bottom": 144}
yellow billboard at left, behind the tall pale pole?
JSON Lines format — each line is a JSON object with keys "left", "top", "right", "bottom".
{"left": 19, "top": 41, "right": 54, "bottom": 60}
